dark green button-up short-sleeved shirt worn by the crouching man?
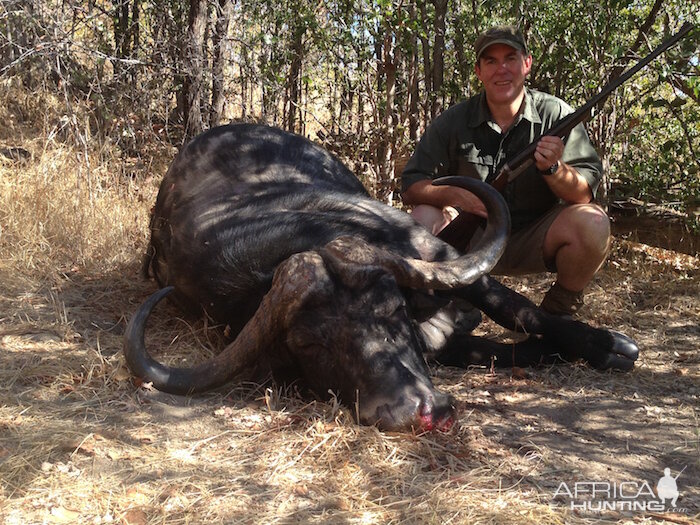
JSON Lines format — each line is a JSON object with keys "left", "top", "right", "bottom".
{"left": 401, "top": 88, "right": 603, "bottom": 231}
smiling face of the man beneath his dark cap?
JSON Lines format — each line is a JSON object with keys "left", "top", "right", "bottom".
{"left": 475, "top": 44, "right": 532, "bottom": 104}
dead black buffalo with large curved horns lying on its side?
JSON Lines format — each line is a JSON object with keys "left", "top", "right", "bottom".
{"left": 124, "top": 124, "right": 638, "bottom": 429}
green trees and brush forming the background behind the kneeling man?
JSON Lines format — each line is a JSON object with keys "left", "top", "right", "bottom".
{"left": 0, "top": 0, "right": 700, "bottom": 225}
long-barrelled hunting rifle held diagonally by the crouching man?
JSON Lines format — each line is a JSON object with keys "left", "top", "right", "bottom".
{"left": 433, "top": 22, "right": 693, "bottom": 251}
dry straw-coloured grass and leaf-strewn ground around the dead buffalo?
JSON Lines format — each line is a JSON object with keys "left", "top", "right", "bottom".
{"left": 0, "top": 80, "right": 700, "bottom": 524}
